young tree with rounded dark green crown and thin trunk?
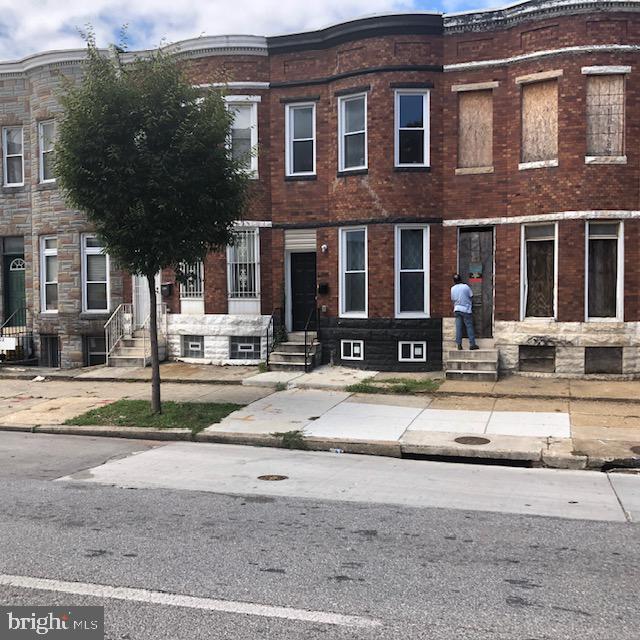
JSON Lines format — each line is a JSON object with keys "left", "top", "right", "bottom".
{"left": 55, "top": 35, "right": 248, "bottom": 413}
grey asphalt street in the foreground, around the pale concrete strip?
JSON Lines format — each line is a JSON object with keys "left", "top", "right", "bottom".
{"left": 0, "top": 433, "right": 640, "bottom": 640}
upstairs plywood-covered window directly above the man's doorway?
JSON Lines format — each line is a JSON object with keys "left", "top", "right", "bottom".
{"left": 458, "top": 90, "right": 493, "bottom": 169}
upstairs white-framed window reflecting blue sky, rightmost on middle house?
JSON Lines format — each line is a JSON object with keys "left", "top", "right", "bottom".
{"left": 395, "top": 90, "right": 429, "bottom": 167}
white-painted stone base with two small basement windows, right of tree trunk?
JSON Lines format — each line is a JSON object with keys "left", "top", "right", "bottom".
{"left": 167, "top": 313, "right": 271, "bottom": 365}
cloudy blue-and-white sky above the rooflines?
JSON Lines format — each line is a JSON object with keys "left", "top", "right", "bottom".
{"left": 0, "top": 0, "right": 498, "bottom": 61}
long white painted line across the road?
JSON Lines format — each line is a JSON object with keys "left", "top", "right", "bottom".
{"left": 0, "top": 574, "right": 382, "bottom": 628}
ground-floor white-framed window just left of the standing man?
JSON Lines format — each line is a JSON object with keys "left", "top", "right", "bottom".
{"left": 396, "top": 225, "right": 429, "bottom": 318}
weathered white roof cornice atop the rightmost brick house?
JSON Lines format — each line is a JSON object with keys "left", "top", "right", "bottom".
{"left": 444, "top": 0, "right": 640, "bottom": 33}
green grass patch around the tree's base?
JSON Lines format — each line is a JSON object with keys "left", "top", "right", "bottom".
{"left": 65, "top": 400, "right": 241, "bottom": 434}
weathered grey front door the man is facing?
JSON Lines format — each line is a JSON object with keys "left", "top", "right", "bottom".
{"left": 458, "top": 227, "right": 493, "bottom": 338}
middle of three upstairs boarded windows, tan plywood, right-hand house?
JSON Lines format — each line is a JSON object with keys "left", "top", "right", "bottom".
{"left": 522, "top": 80, "right": 558, "bottom": 162}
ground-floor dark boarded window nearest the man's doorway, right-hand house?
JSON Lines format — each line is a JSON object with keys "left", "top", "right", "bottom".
{"left": 522, "top": 224, "right": 556, "bottom": 318}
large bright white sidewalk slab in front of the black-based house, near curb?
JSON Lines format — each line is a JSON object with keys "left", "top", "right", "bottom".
{"left": 304, "top": 402, "right": 421, "bottom": 441}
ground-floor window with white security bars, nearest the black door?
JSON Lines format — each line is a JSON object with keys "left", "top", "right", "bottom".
{"left": 227, "top": 229, "right": 260, "bottom": 298}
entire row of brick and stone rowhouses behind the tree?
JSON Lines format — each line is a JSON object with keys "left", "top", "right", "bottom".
{"left": 0, "top": 0, "right": 640, "bottom": 375}
